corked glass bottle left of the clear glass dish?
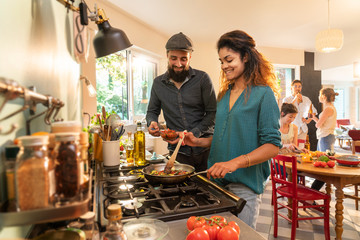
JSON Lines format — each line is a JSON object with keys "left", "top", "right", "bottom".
{"left": 102, "top": 204, "right": 127, "bottom": 240}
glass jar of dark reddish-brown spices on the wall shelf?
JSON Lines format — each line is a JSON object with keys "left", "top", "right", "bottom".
{"left": 54, "top": 132, "right": 84, "bottom": 204}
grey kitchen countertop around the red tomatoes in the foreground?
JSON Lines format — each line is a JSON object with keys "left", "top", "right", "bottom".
{"left": 164, "top": 212, "right": 265, "bottom": 240}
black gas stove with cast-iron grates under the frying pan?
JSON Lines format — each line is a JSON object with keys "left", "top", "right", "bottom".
{"left": 95, "top": 164, "right": 246, "bottom": 227}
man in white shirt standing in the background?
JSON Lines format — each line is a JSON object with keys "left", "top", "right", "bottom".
{"left": 283, "top": 79, "right": 317, "bottom": 148}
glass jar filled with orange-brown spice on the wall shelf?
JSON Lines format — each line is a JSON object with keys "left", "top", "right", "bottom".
{"left": 15, "top": 136, "right": 55, "bottom": 211}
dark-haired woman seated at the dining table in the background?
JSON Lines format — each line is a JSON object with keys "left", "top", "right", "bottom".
{"left": 280, "top": 103, "right": 298, "bottom": 152}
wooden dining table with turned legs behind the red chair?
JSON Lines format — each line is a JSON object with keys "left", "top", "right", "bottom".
{"left": 283, "top": 153, "right": 360, "bottom": 240}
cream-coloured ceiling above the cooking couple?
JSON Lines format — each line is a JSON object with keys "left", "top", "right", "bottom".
{"left": 108, "top": 0, "right": 360, "bottom": 52}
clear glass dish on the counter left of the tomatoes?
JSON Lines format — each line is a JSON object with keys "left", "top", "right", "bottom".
{"left": 124, "top": 218, "right": 169, "bottom": 240}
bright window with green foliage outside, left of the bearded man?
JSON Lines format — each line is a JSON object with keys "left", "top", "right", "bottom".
{"left": 96, "top": 50, "right": 158, "bottom": 121}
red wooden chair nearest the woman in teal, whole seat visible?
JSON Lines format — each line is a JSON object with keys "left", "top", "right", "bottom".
{"left": 271, "top": 155, "right": 330, "bottom": 240}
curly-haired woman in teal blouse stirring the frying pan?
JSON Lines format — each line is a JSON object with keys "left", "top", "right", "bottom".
{"left": 184, "top": 30, "right": 281, "bottom": 228}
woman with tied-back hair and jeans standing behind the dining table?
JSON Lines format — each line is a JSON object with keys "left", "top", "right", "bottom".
{"left": 311, "top": 88, "right": 339, "bottom": 190}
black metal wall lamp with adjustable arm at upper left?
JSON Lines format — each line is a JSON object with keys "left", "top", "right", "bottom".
{"left": 57, "top": 0, "right": 132, "bottom": 58}
